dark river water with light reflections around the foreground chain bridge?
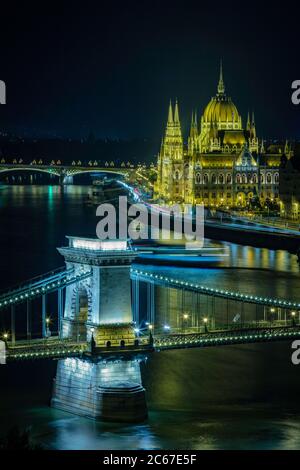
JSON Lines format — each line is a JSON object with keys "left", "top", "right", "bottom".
{"left": 0, "top": 186, "right": 300, "bottom": 449}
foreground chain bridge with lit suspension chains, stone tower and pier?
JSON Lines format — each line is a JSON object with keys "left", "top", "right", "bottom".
{"left": 0, "top": 237, "right": 300, "bottom": 421}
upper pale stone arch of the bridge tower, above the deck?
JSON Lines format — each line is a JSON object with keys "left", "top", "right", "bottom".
{"left": 58, "top": 237, "right": 137, "bottom": 346}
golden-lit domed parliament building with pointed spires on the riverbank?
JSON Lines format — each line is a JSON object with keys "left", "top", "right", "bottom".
{"left": 155, "top": 65, "right": 292, "bottom": 207}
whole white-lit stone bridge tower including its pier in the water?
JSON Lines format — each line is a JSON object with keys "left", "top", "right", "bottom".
{"left": 52, "top": 237, "right": 147, "bottom": 421}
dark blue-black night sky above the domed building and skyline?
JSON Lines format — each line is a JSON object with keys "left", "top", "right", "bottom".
{"left": 0, "top": 0, "right": 300, "bottom": 139}
